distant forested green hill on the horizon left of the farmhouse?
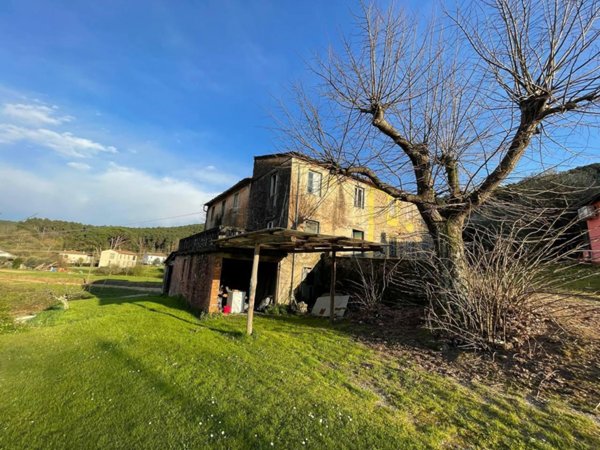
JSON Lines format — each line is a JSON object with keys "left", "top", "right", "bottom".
{"left": 0, "top": 218, "right": 204, "bottom": 255}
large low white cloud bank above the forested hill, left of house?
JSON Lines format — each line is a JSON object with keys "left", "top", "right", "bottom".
{"left": 0, "top": 164, "right": 215, "bottom": 226}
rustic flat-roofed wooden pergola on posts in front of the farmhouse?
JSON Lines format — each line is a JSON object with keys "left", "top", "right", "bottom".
{"left": 214, "top": 228, "right": 383, "bottom": 334}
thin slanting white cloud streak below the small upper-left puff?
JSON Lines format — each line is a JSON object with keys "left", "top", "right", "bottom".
{"left": 0, "top": 124, "right": 117, "bottom": 158}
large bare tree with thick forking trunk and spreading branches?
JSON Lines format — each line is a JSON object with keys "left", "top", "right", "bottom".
{"left": 282, "top": 0, "right": 600, "bottom": 296}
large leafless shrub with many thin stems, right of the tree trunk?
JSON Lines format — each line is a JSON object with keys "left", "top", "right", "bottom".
{"left": 424, "top": 211, "right": 582, "bottom": 350}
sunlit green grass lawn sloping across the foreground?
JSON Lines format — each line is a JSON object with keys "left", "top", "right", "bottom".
{"left": 0, "top": 284, "right": 600, "bottom": 449}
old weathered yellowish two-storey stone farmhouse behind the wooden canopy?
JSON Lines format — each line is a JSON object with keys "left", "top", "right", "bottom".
{"left": 164, "top": 153, "right": 427, "bottom": 312}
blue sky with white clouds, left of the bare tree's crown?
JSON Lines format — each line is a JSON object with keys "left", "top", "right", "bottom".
{"left": 0, "top": 0, "right": 596, "bottom": 226}
